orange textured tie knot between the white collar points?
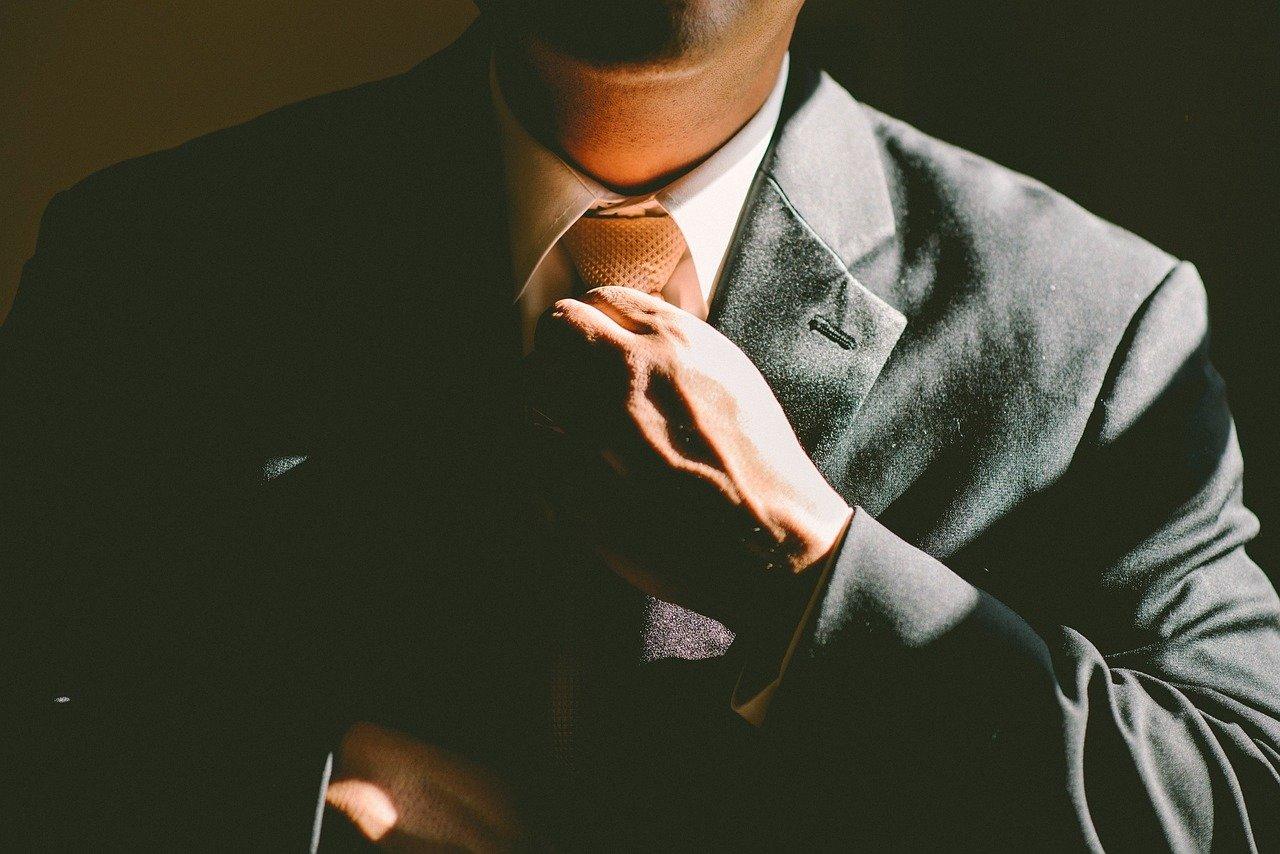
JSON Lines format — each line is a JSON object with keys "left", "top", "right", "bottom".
{"left": 563, "top": 214, "right": 685, "bottom": 293}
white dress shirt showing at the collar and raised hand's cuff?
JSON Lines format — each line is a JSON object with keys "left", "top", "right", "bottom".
{"left": 489, "top": 55, "right": 831, "bottom": 726}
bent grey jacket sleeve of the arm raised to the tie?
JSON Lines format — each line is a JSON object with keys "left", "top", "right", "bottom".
{"left": 768, "top": 264, "right": 1280, "bottom": 850}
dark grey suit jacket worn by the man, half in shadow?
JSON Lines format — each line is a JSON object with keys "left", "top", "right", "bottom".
{"left": 0, "top": 23, "right": 1280, "bottom": 850}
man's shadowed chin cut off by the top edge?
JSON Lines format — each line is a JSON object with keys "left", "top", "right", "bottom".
{"left": 479, "top": 0, "right": 747, "bottom": 67}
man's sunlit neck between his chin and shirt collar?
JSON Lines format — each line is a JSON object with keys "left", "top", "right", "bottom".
{"left": 497, "top": 27, "right": 791, "bottom": 195}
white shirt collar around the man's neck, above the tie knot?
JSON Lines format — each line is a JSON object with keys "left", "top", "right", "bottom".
{"left": 489, "top": 55, "right": 790, "bottom": 314}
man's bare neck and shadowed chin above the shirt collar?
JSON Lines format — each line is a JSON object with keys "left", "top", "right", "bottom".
{"left": 481, "top": 0, "right": 801, "bottom": 193}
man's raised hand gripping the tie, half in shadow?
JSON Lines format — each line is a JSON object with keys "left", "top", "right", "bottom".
{"left": 527, "top": 287, "right": 851, "bottom": 630}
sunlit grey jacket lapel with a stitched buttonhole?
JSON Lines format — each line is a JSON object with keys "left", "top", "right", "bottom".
{"left": 709, "top": 58, "right": 906, "bottom": 488}
